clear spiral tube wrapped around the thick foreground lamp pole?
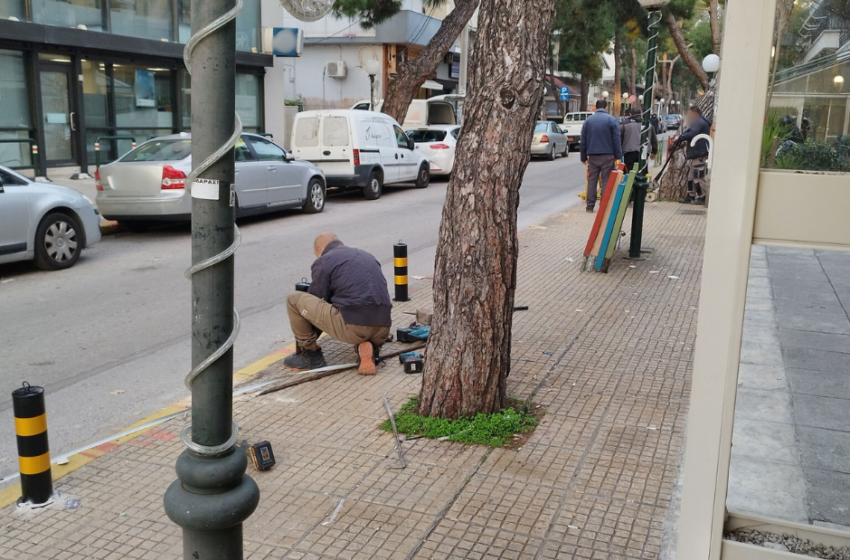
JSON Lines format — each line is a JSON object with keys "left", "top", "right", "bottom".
{"left": 180, "top": 0, "right": 243, "bottom": 456}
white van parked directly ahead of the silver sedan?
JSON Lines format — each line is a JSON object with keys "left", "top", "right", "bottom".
{"left": 292, "top": 109, "right": 431, "bottom": 200}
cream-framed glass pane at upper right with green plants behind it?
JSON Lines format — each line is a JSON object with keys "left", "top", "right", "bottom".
{"left": 762, "top": 0, "right": 850, "bottom": 172}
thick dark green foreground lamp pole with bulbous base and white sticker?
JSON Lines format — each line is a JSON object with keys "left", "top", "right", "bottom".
{"left": 164, "top": 0, "right": 260, "bottom": 560}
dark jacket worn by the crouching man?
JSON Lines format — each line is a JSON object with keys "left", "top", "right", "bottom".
{"left": 309, "top": 241, "right": 393, "bottom": 327}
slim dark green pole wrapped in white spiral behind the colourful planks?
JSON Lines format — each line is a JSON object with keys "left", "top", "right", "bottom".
{"left": 629, "top": 0, "right": 669, "bottom": 259}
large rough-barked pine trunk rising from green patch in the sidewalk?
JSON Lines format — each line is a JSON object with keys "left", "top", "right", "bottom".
{"left": 419, "top": 0, "right": 555, "bottom": 418}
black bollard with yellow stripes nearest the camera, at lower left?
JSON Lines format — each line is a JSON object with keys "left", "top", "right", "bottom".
{"left": 12, "top": 382, "right": 53, "bottom": 504}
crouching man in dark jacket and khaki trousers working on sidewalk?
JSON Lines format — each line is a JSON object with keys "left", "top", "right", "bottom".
{"left": 283, "top": 232, "right": 393, "bottom": 375}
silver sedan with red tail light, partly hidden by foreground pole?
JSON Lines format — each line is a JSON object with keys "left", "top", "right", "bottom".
{"left": 95, "top": 133, "right": 327, "bottom": 229}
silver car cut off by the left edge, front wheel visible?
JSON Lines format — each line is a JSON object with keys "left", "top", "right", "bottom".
{"left": 0, "top": 166, "right": 100, "bottom": 270}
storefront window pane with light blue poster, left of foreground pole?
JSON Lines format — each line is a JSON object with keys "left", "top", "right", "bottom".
{"left": 113, "top": 64, "right": 174, "bottom": 129}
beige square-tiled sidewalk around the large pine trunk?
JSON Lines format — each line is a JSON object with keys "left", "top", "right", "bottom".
{"left": 0, "top": 203, "right": 705, "bottom": 560}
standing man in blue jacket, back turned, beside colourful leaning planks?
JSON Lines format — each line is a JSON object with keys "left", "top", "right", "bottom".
{"left": 581, "top": 99, "right": 623, "bottom": 212}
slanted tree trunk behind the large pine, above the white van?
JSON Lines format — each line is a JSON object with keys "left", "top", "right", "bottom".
{"left": 382, "top": 0, "right": 478, "bottom": 124}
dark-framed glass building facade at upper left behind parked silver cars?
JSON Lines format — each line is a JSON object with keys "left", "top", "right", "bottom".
{"left": 0, "top": 0, "right": 273, "bottom": 175}
